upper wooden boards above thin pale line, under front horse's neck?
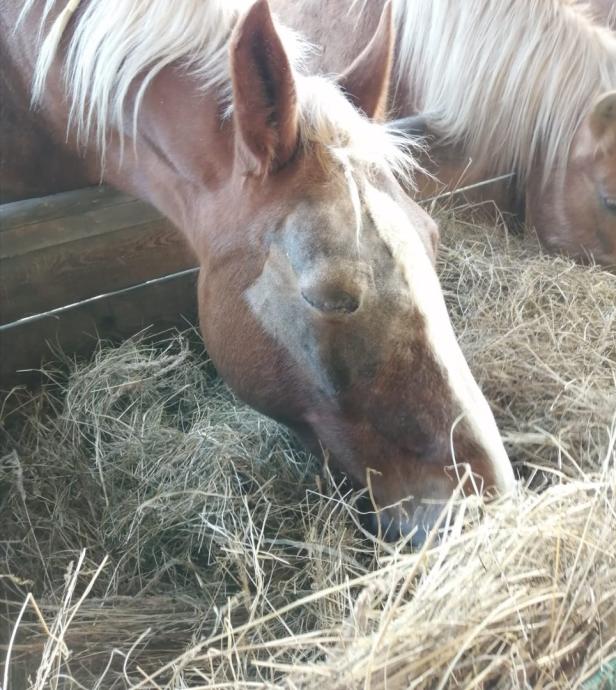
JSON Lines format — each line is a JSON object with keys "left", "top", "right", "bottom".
{"left": 0, "top": 188, "right": 196, "bottom": 324}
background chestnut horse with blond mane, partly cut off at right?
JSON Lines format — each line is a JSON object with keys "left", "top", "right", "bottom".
{"left": 274, "top": 0, "right": 616, "bottom": 266}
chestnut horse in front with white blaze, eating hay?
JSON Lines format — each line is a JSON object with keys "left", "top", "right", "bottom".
{"left": 0, "top": 0, "right": 514, "bottom": 543}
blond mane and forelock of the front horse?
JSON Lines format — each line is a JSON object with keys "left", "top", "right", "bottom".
{"left": 22, "top": 0, "right": 415, "bottom": 183}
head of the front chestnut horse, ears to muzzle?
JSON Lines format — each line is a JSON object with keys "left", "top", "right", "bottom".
{"left": 199, "top": 3, "right": 513, "bottom": 541}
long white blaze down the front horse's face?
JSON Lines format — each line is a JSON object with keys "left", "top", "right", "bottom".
{"left": 364, "top": 183, "right": 515, "bottom": 493}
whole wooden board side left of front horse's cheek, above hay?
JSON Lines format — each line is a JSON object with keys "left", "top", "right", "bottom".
{"left": 0, "top": 187, "right": 196, "bottom": 392}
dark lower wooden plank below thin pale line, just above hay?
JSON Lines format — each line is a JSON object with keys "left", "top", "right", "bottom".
{"left": 0, "top": 271, "right": 197, "bottom": 392}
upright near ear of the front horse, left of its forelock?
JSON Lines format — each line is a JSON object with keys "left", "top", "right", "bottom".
{"left": 231, "top": 0, "right": 299, "bottom": 175}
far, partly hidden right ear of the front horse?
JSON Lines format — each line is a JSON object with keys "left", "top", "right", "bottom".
{"left": 338, "top": 0, "right": 395, "bottom": 120}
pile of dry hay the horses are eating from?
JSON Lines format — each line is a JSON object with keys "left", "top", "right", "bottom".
{"left": 0, "top": 216, "right": 616, "bottom": 690}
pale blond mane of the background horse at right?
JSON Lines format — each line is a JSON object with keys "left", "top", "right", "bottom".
{"left": 395, "top": 0, "right": 616, "bottom": 184}
